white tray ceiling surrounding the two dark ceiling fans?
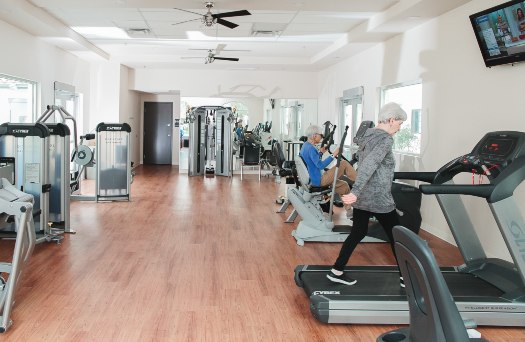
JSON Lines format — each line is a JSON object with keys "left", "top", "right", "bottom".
{"left": 0, "top": 0, "right": 469, "bottom": 71}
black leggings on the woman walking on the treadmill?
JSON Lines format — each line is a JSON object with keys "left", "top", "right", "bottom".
{"left": 334, "top": 208, "right": 399, "bottom": 271}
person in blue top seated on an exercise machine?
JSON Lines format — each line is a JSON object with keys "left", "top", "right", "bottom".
{"left": 299, "top": 125, "right": 357, "bottom": 214}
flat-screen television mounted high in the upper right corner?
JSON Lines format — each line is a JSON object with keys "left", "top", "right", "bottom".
{"left": 470, "top": 0, "right": 525, "bottom": 67}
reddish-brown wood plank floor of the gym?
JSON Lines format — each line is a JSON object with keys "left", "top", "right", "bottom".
{"left": 0, "top": 166, "right": 525, "bottom": 342}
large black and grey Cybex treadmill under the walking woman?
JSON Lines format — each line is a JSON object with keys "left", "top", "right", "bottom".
{"left": 295, "top": 131, "right": 525, "bottom": 326}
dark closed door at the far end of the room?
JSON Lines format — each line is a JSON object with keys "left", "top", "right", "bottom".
{"left": 143, "top": 102, "right": 173, "bottom": 164}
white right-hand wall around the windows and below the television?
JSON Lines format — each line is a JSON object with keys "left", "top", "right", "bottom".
{"left": 318, "top": 0, "right": 525, "bottom": 257}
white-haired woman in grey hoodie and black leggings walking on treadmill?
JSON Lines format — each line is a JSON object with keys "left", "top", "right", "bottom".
{"left": 327, "top": 103, "right": 407, "bottom": 287}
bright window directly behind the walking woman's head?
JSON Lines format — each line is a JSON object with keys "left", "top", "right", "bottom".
{"left": 381, "top": 81, "right": 422, "bottom": 154}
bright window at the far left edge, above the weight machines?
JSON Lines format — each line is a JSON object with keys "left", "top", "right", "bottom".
{"left": 0, "top": 74, "right": 37, "bottom": 124}
